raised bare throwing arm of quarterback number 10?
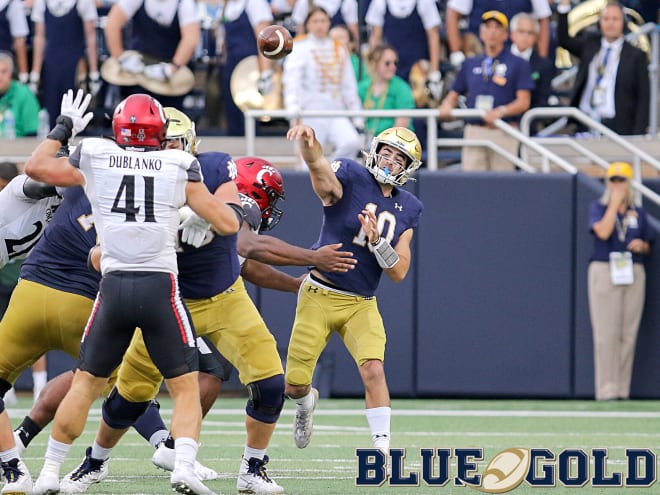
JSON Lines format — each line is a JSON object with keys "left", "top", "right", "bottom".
{"left": 286, "top": 125, "right": 343, "bottom": 206}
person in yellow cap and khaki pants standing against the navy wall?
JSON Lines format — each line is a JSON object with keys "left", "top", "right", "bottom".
{"left": 588, "top": 162, "right": 655, "bottom": 400}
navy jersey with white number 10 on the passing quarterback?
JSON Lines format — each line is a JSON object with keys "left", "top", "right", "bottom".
{"left": 312, "top": 158, "right": 424, "bottom": 296}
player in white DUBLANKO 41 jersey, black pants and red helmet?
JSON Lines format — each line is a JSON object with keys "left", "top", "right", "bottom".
{"left": 25, "top": 90, "right": 243, "bottom": 495}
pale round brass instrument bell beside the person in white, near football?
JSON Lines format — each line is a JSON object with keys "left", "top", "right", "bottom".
{"left": 229, "top": 55, "right": 283, "bottom": 122}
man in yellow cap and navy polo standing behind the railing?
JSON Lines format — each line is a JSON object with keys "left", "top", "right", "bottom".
{"left": 439, "top": 10, "right": 534, "bottom": 171}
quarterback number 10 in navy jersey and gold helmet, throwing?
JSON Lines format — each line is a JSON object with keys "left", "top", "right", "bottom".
{"left": 286, "top": 125, "right": 423, "bottom": 460}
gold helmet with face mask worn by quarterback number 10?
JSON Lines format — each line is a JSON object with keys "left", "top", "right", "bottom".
{"left": 365, "top": 127, "right": 422, "bottom": 186}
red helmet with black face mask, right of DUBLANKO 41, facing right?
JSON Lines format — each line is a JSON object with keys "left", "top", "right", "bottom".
{"left": 235, "top": 156, "right": 284, "bottom": 231}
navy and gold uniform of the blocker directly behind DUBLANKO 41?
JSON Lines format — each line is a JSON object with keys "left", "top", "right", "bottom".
{"left": 117, "top": 152, "right": 284, "bottom": 402}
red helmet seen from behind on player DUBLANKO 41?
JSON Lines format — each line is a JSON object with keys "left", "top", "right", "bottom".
{"left": 112, "top": 94, "right": 167, "bottom": 149}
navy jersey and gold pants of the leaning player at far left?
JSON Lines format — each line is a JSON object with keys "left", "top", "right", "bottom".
{"left": 0, "top": 187, "right": 100, "bottom": 383}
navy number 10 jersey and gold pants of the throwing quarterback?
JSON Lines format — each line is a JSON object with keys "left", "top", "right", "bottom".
{"left": 286, "top": 159, "right": 423, "bottom": 385}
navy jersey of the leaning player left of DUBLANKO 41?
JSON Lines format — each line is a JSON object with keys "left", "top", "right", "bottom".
{"left": 21, "top": 187, "right": 101, "bottom": 299}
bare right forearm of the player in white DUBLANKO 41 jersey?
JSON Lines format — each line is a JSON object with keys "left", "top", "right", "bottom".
{"left": 186, "top": 182, "right": 243, "bottom": 235}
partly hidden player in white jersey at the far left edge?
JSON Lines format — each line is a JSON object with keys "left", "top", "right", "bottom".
{"left": 0, "top": 174, "right": 62, "bottom": 268}
